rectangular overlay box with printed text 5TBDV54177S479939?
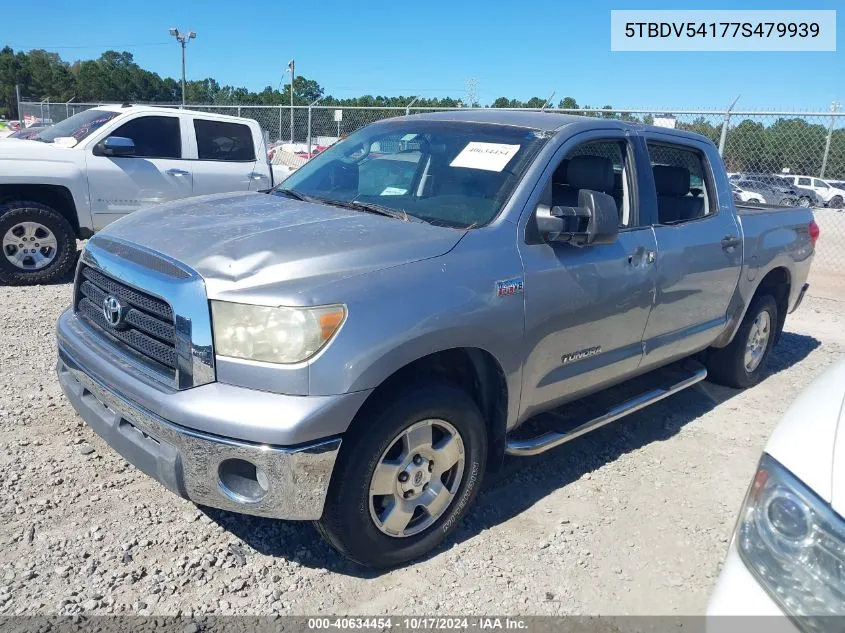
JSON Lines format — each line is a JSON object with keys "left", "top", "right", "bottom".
{"left": 610, "top": 10, "right": 836, "bottom": 51}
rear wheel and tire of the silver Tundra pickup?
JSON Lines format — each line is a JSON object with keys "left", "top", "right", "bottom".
{"left": 707, "top": 295, "right": 779, "bottom": 389}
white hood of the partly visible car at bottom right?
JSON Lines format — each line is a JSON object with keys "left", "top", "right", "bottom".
{"left": 765, "top": 361, "right": 845, "bottom": 516}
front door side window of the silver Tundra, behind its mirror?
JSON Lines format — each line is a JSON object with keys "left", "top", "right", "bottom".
{"left": 550, "top": 141, "right": 632, "bottom": 228}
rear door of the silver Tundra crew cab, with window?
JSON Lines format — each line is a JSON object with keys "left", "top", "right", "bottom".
{"left": 641, "top": 132, "right": 742, "bottom": 368}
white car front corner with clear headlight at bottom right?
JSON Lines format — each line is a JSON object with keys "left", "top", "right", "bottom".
{"left": 707, "top": 361, "right": 845, "bottom": 632}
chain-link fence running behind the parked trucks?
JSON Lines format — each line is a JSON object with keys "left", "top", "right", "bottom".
{"left": 19, "top": 101, "right": 845, "bottom": 275}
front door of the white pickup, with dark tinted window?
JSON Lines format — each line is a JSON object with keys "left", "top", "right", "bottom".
{"left": 86, "top": 114, "right": 193, "bottom": 230}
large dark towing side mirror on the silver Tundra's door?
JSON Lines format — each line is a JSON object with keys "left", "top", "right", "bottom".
{"left": 537, "top": 189, "right": 619, "bottom": 246}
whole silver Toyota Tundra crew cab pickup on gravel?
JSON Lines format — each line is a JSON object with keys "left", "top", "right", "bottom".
{"left": 57, "top": 110, "right": 818, "bottom": 567}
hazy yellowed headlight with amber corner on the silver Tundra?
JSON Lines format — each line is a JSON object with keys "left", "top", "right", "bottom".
{"left": 211, "top": 301, "right": 346, "bottom": 363}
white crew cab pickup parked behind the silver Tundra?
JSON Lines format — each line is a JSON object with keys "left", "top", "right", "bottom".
{"left": 0, "top": 105, "right": 288, "bottom": 285}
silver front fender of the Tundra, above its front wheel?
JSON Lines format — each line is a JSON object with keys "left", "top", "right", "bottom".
{"left": 309, "top": 224, "right": 524, "bottom": 423}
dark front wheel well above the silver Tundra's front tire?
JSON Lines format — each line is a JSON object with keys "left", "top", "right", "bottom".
{"left": 347, "top": 347, "right": 510, "bottom": 470}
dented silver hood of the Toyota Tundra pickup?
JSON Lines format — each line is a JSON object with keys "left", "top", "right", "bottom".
{"left": 99, "top": 193, "right": 465, "bottom": 304}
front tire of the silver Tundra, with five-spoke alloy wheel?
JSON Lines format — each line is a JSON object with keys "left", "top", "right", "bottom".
{"left": 316, "top": 379, "right": 487, "bottom": 569}
